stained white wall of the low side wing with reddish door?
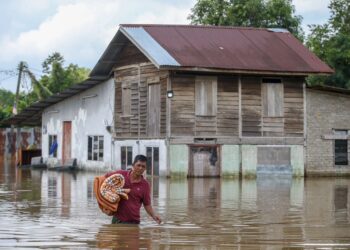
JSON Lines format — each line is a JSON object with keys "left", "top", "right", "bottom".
{"left": 42, "top": 79, "right": 115, "bottom": 170}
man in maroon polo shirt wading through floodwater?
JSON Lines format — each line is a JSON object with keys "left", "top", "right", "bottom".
{"left": 105, "top": 155, "right": 162, "bottom": 224}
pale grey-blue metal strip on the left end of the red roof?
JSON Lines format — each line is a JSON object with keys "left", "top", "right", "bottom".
{"left": 120, "top": 27, "right": 180, "bottom": 67}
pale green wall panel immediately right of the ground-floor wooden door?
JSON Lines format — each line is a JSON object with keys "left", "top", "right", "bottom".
{"left": 221, "top": 145, "right": 240, "bottom": 178}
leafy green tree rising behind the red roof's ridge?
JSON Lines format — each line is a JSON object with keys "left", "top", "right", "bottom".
{"left": 188, "top": 0, "right": 304, "bottom": 41}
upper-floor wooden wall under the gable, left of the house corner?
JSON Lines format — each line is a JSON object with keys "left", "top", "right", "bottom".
{"left": 114, "top": 63, "right": 167, "bottom": 138}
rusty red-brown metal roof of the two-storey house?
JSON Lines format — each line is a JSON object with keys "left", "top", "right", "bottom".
{"left": 120, "top": 24, "right": 333, "bottom": 75}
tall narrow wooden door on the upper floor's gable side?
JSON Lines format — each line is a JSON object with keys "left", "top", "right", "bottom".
{"left": 147, "top": 84, "right": 160, "bottom": 137}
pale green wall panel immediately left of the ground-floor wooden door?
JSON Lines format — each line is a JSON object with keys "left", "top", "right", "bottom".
{"left": 169, "top": 145, "right": 189, "bottom": 177}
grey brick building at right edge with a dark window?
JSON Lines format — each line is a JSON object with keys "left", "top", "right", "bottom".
{"left": 305, "top": 87, "right": 350, "bottom": 176}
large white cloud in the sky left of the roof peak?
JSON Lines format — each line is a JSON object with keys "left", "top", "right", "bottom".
{"left": 0, "top": 0, "right": 193, "bottom": 91}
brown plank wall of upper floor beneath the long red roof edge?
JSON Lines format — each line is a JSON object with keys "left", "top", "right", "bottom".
{"left": 170, "top": 75, "right": 304, "bottom": 138}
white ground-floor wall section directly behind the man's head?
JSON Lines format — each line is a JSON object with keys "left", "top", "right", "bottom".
{"left": 112, "top": 140, "right": 167, "bottom": 176}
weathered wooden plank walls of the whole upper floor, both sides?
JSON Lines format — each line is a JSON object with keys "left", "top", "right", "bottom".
{"left": 114, "top": 63, "right": 304, "bottom": 138}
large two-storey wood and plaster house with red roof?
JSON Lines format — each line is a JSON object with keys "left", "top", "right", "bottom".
{"left": 2, "top": 25, "right": 342, "bottom": 177}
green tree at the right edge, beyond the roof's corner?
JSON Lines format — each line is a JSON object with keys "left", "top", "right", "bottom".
{"left": 306, "top": 0, "right": 350, "bottom": 89}
